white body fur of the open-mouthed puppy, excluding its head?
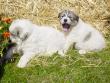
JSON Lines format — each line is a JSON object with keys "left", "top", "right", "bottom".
{"left": 65, "top": 18, "right": 106, "bottom": 54}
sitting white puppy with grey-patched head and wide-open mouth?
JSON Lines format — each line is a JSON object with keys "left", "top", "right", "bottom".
{"left": 58, "top": 10, "right": 105, "bottom": 54}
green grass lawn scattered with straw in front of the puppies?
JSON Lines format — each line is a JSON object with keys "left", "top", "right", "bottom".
{"left": 1, "top": 42, "right": 110, "bottom": 83}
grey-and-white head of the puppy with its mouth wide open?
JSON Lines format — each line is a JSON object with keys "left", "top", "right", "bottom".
{"left": 58, "top": 10, "right": 79, "bottom": 32}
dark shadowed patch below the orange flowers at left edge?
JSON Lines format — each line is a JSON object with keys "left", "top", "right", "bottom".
{"left": 0, "top": 40, "right": 15, "bottom": 80}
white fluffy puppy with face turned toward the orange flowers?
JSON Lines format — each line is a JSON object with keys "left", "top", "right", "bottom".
{"left": 9, "top": 19, "right": 65, "bottom": 68}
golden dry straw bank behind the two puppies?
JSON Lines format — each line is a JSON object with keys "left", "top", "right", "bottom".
{"left": 0, "top": 0, "right": 110, "bottom": 34}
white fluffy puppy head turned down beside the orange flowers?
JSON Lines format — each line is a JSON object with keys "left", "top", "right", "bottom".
{"left": 9, "top": 19, "right": 32, "bottom": 43}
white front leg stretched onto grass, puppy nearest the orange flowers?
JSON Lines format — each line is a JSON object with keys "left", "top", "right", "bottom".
{"left": 17, "top": 52, "right": 35, "bottom": 68}
